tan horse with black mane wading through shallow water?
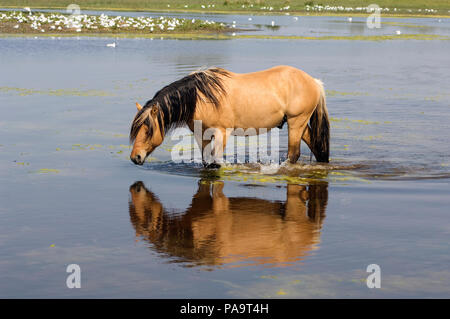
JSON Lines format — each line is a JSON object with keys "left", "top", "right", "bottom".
{"left": 130, "top": 65, "right": 330, "bottom": 167}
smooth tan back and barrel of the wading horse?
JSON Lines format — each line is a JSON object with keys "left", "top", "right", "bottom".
{"left": 195, "top": 65, "right": 319, "bottom": 129}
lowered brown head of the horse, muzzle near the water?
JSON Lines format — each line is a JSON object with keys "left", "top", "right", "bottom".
{"left": 130, "top": 103, "right": 164, "bottom": 165}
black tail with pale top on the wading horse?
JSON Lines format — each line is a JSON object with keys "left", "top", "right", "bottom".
{"left": 309, "top": 79, "right": 330, "bottom": 163}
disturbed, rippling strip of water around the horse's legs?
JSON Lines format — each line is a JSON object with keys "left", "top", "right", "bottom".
{"left": 138, "top": 160, "right": 450, "bottom": 184}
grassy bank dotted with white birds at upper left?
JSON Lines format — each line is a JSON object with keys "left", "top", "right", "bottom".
{"left": 0, "top": 10, "right": 230, "bottom": 36}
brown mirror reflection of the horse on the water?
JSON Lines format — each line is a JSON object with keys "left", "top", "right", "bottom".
{"left": 129, "top": 180, "right": 328, "bottom": 267}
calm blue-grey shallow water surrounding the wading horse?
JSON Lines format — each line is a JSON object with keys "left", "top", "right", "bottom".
{"left": 0, "top": 11, "right": 450, "bottom": 298}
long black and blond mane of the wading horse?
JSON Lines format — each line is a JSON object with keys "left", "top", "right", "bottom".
{"left": 130, "top": 68, "right": 229, "bottom": 142}
